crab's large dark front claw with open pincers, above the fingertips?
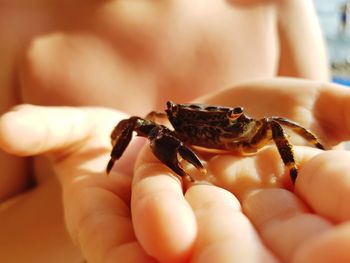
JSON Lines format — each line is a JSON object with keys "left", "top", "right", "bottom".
{"left": 149, "top": 126, "right": 206, "bottom": 181}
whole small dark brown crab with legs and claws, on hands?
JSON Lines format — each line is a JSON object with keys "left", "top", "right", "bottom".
{"left": 106, "top": 101, "right": 324, "bottom": 184}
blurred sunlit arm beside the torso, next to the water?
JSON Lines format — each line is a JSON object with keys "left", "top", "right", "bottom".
{"left": 277, "top": 0, "right": 330, "bottom": 81}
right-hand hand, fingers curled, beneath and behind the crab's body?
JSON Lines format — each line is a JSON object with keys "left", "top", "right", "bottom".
{"left": 131, "top": 79, "right": 350, "bottom": 262}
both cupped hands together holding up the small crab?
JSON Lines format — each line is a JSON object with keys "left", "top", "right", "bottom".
{"left": 0, "top": 79, "right": 350, "bottom": 262}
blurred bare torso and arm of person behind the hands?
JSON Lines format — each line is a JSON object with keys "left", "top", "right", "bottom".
{"left": 0, "top": 0, "right": 328, "bottom": 263}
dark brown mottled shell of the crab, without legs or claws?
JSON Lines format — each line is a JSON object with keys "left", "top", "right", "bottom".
{"left": 165, "top": 101, "right": 260, "bottom": 150}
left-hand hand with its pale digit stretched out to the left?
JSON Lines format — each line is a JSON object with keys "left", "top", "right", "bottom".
{"left": 0, "top": 105, "right": 153, "bottom": 262}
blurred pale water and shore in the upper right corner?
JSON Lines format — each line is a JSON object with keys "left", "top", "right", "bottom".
{"left": 314, "top": 0, "right": 350, "bottom": 86}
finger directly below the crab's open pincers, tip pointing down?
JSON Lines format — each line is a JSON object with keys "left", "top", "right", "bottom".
{"left": 131, "top": 148, "right": 197, "bottom": 262}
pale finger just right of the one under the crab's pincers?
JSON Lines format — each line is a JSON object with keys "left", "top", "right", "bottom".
{"left": 186, "top": 185, "right": 277, "bottom": 262}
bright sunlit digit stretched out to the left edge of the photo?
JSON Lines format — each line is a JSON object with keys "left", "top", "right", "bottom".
{"left": 0, "top": 105, "right": 121, "bottom": 159}
